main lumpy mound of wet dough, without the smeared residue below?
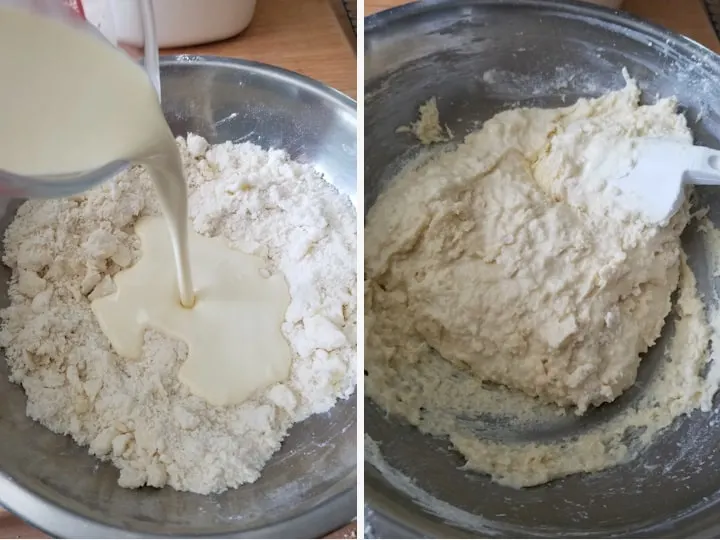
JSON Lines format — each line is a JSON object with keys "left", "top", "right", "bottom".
{"left": 365, "top": 76, "right": 692, "bottom": 413}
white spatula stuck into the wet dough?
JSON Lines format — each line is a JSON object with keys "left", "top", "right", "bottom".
{"left": 610, "top": 138, "right": 720, "bottom": 224}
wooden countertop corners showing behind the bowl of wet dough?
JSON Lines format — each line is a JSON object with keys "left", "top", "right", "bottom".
{"left": 365, "top": 0, "right": 720, "bottom": 53}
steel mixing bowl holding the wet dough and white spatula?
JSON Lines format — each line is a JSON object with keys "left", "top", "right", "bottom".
{"left": 365, "top": 0, "right": 720, "bottom": 538}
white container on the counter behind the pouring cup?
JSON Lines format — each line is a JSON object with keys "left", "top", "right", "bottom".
{"left": 83, "top": 0, "right": 256, "bottom": 48}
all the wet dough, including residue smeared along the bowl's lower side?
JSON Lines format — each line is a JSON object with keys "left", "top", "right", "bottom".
{"left": 365, "top": 75, "right": 717, "bottom": 486}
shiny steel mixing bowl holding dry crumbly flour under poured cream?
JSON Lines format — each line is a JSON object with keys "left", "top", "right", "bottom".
{"left": 0, "top": 56, "right": 356, "bottom": 538}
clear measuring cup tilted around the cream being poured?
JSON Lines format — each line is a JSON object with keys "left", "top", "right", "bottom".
{"left": 0, "top": 0, "right": 160, "bottom": 198}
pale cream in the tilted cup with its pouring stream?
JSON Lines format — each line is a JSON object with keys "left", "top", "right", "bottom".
{"left": 0, "top": 5, "right": 194, "bottom": 306}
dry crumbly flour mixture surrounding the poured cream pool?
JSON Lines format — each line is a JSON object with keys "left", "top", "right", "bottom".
{"left": 0, "top": 135, "right": 357, "bottom": 493}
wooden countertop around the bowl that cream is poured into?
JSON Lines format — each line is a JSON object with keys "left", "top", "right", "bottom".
{"left": 0, "top": 0, "right": 357, "bottom": 538}
